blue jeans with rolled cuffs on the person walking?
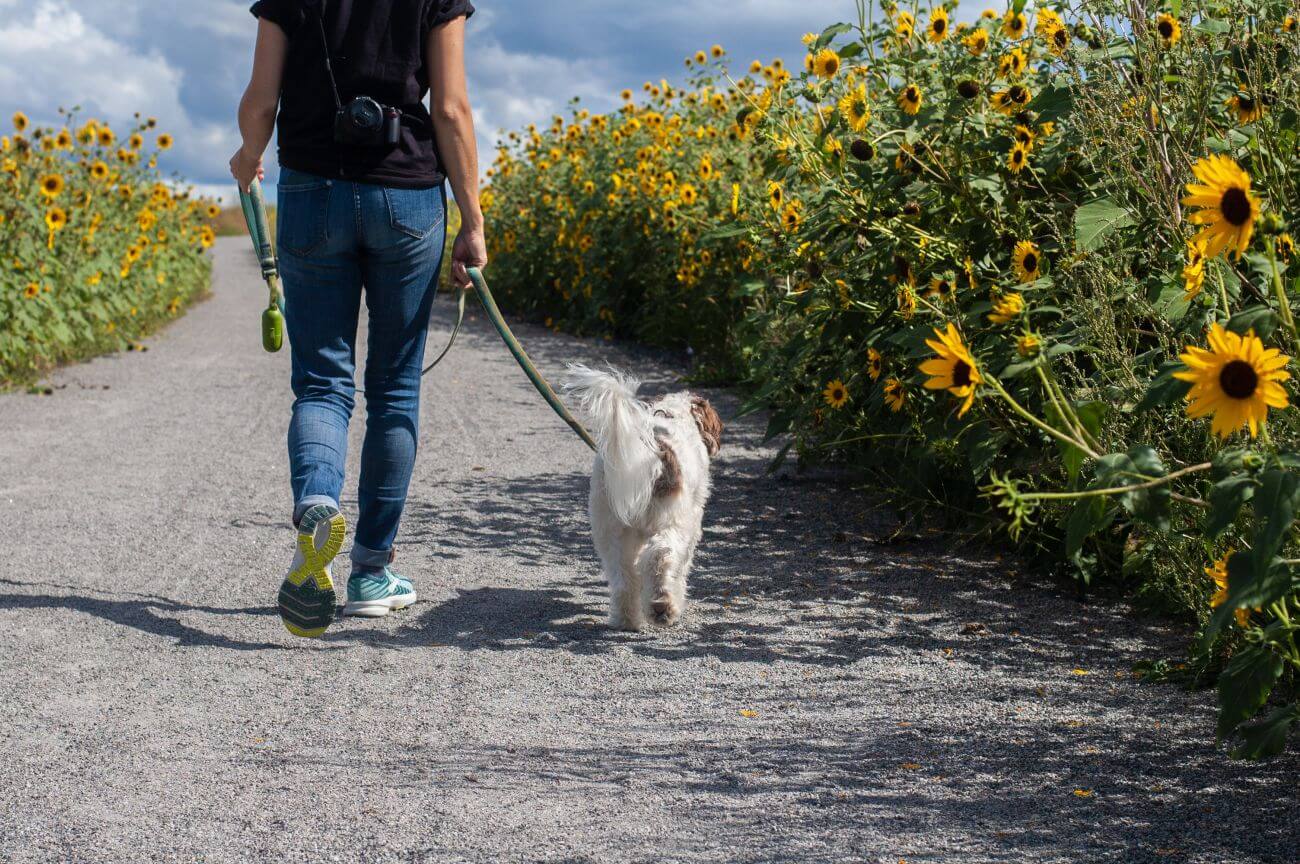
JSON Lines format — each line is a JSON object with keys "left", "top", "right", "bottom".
{"left": 277, "top": 169, "right": 447, "bottom": 570}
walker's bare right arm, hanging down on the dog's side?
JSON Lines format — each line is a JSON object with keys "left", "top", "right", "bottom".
{"left": 425, "top": 18, "right": 488, "bottom": 288}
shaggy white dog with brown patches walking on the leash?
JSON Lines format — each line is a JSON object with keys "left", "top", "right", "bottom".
{"left": 564, "top": 365, "right": 723, "bottom": 630}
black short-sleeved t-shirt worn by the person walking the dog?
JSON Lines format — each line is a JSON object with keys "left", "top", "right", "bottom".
{"left": 252, "top": 0, "right": 475, "bottom": 188}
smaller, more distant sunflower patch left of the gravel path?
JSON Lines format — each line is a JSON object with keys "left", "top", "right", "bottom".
{"left": 0, "top": 112, "right": 220, "bottom": 387}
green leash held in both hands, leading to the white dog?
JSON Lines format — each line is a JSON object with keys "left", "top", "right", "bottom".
{"left": 239, "top": 179, "right": 597, "bottom": 450}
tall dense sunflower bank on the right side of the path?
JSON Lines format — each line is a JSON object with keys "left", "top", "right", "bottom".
{"left": 484, "top": 0, "right": 1300, "bottom": 756}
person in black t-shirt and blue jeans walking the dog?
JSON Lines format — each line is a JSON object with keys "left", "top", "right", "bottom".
{"left": 230, "top": 0, "right": 488, "bottom": 637}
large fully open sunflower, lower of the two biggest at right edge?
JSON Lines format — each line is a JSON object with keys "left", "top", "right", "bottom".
{"left": 1174, "top": 324, "right": 1291, "bottom": 438}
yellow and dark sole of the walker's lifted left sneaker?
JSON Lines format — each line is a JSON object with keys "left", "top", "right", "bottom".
{"left": 276, "top": 504, "right": 347, "bottom": 639}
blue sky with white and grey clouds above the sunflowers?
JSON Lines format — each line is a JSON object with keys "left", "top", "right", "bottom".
{"left": 0, "top": 0, "right": 855, "bottom": 200}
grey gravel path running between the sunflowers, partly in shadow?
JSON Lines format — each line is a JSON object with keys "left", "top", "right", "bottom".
{"left": 0, "top": 239, "right": 1300, "bottom": 864}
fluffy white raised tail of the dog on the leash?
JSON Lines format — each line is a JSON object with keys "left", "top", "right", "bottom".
{"left": 564, "top": 364, "right": 663, "bottom": 525}
